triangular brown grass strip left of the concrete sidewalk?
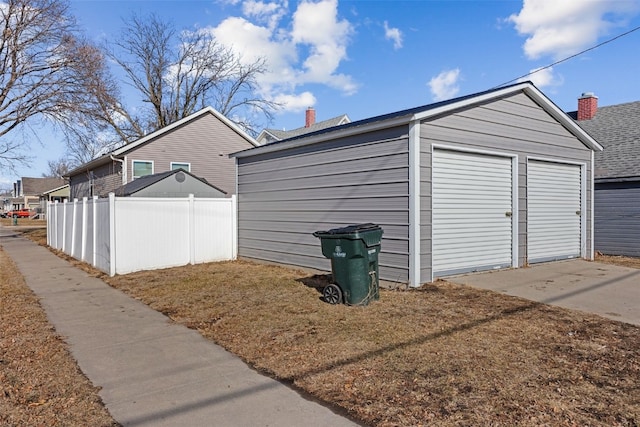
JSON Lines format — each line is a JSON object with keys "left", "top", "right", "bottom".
{"left": 0, "top": 249, "right": 118, "bottom": 426}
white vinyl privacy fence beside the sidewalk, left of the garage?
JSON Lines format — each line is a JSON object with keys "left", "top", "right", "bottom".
{"left": 47, "top": 194, "right": 237, "bottom": 276}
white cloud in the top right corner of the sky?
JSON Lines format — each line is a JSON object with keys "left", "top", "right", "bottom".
{"left": 507, "top": 0, "right": 640, "bottom": 59}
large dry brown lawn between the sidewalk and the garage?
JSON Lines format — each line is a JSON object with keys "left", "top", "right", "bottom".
{"left": 11, "top": 231, "right": 640, "bottom": 426}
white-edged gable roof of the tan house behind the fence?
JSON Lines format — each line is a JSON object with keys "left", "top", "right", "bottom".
{"left": 66, "top": 107, "right": 260, "bottom": 176}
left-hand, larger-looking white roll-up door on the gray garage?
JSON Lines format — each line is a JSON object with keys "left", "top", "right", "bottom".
{"left": 432, "top": 149, "right": 513, "bottom": 277}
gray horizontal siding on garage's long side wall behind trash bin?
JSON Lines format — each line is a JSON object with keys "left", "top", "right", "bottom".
{"left": 238, "top": 126, "right": 409, "bottom": 282}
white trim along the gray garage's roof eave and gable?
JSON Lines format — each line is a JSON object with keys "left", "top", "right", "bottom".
{"left": 230, "top": 82, "right": 603, "bottom": 158}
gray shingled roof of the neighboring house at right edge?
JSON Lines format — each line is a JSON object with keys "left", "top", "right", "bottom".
{"left": 569, "top": 101, "right": 640, "bottom": 182}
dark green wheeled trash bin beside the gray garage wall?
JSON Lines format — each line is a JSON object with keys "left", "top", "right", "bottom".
{"left": 313, "top": 223, "right": 383, "bottom": 305}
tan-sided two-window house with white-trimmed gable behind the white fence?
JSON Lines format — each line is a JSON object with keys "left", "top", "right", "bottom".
{"left": 63, "top": 107, "right": 258, "bottom": 199}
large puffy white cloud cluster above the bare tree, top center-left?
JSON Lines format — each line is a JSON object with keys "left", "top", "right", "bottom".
{"left": 208, "top": 0, "right": 358, "bottom": 111}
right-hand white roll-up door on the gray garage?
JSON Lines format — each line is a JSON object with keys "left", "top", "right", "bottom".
{"left": 527, "top": 160, "right": 582, "bottom": 263}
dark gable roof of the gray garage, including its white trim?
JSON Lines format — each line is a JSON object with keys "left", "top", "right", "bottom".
{"left": 230, "top": 82, "right": 602, "bottom": 158}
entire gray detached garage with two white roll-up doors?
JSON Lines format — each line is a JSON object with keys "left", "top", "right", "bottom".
{"left": 233, "top": 82, "right": 601, "bottom": 286}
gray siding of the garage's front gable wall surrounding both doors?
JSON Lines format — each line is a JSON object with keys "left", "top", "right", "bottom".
{"left": 420, "top": 93, "right": 592, "bottom": 282}
